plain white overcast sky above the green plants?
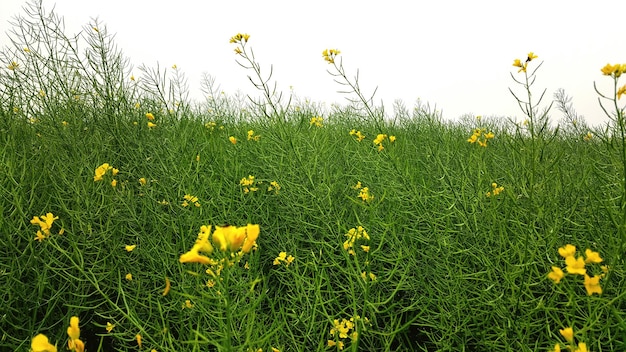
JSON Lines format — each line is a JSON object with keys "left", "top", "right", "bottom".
{"left": 0, "top": 0, "right": 626, "bottom": 124}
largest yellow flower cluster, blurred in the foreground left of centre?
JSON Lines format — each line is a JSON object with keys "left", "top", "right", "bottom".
{"left": 179, "top": 224, "right": 260, "bottom": 265}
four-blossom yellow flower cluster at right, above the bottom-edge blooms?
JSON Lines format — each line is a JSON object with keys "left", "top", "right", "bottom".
{"left": 548, "top": 244, "right": 608, "bottom": 296}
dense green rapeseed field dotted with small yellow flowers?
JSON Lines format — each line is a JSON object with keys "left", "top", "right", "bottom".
{"left": 0, "top": 1, "right": 626, "bottom": 352}
